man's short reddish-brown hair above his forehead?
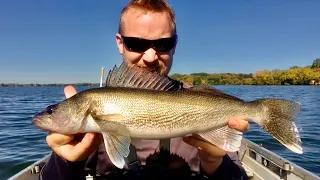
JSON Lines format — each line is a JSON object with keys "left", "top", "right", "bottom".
{"left": 118, "top": 0, "right": 177, "bottom": 34}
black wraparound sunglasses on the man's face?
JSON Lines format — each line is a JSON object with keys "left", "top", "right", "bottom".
{"left": 121, "top": 35, "right": 177, "bottom": 52}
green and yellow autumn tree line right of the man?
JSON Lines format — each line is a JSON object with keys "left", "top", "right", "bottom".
{"left": 170, "top": 58, "right": 320, "bottom": 85}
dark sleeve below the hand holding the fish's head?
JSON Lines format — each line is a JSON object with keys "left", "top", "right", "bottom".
{"left": 40, "top": 152, "right": 86, "bottom": 180}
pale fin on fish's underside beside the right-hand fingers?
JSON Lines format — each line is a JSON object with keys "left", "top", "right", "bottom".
{"left": 199, "top": 126, "right": 242, "bottom": 152}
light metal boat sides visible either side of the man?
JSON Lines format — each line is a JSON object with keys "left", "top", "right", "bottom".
{"left": 9, "top": 138, "right": 320, "bottom": 180}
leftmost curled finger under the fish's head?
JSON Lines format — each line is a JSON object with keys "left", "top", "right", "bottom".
{"left": 46, "top": 132, "right": 74, "bottom": 148}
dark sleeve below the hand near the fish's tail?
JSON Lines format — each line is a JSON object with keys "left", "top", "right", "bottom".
{"left": 200, "top": 152, "right": 248, "bottom": 180}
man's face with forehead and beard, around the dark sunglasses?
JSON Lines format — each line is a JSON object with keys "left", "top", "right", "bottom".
{"left": 116, "top": 9, "right": 175, "bottom": 75}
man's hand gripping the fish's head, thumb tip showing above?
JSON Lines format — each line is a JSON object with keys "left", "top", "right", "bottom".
{"left": 46, "top": 86, "right": 102, "bottom": 162}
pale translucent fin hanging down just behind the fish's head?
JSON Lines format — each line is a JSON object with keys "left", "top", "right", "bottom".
{"left": 102, "top": 132, "right": 130, "bottom": 169}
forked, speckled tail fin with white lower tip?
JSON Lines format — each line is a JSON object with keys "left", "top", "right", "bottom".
{"left": 251, "top": 99, "right": 303, "bottom": 154}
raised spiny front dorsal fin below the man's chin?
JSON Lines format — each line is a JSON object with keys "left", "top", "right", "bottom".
{"left": 106, "top": 63, "right": 183, "bottom": 91}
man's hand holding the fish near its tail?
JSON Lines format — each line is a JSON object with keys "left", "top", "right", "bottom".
{"left": 183, "top": 117, "right": 250, "bottom": 175}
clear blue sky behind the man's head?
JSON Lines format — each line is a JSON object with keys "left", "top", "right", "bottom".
{"left": 0, "top": 0, "right": 320, "bottom": 83}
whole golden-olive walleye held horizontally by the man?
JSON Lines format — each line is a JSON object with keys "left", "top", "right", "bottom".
{"left": 32, "top": 63, "right": 303, "bottom": 169}
